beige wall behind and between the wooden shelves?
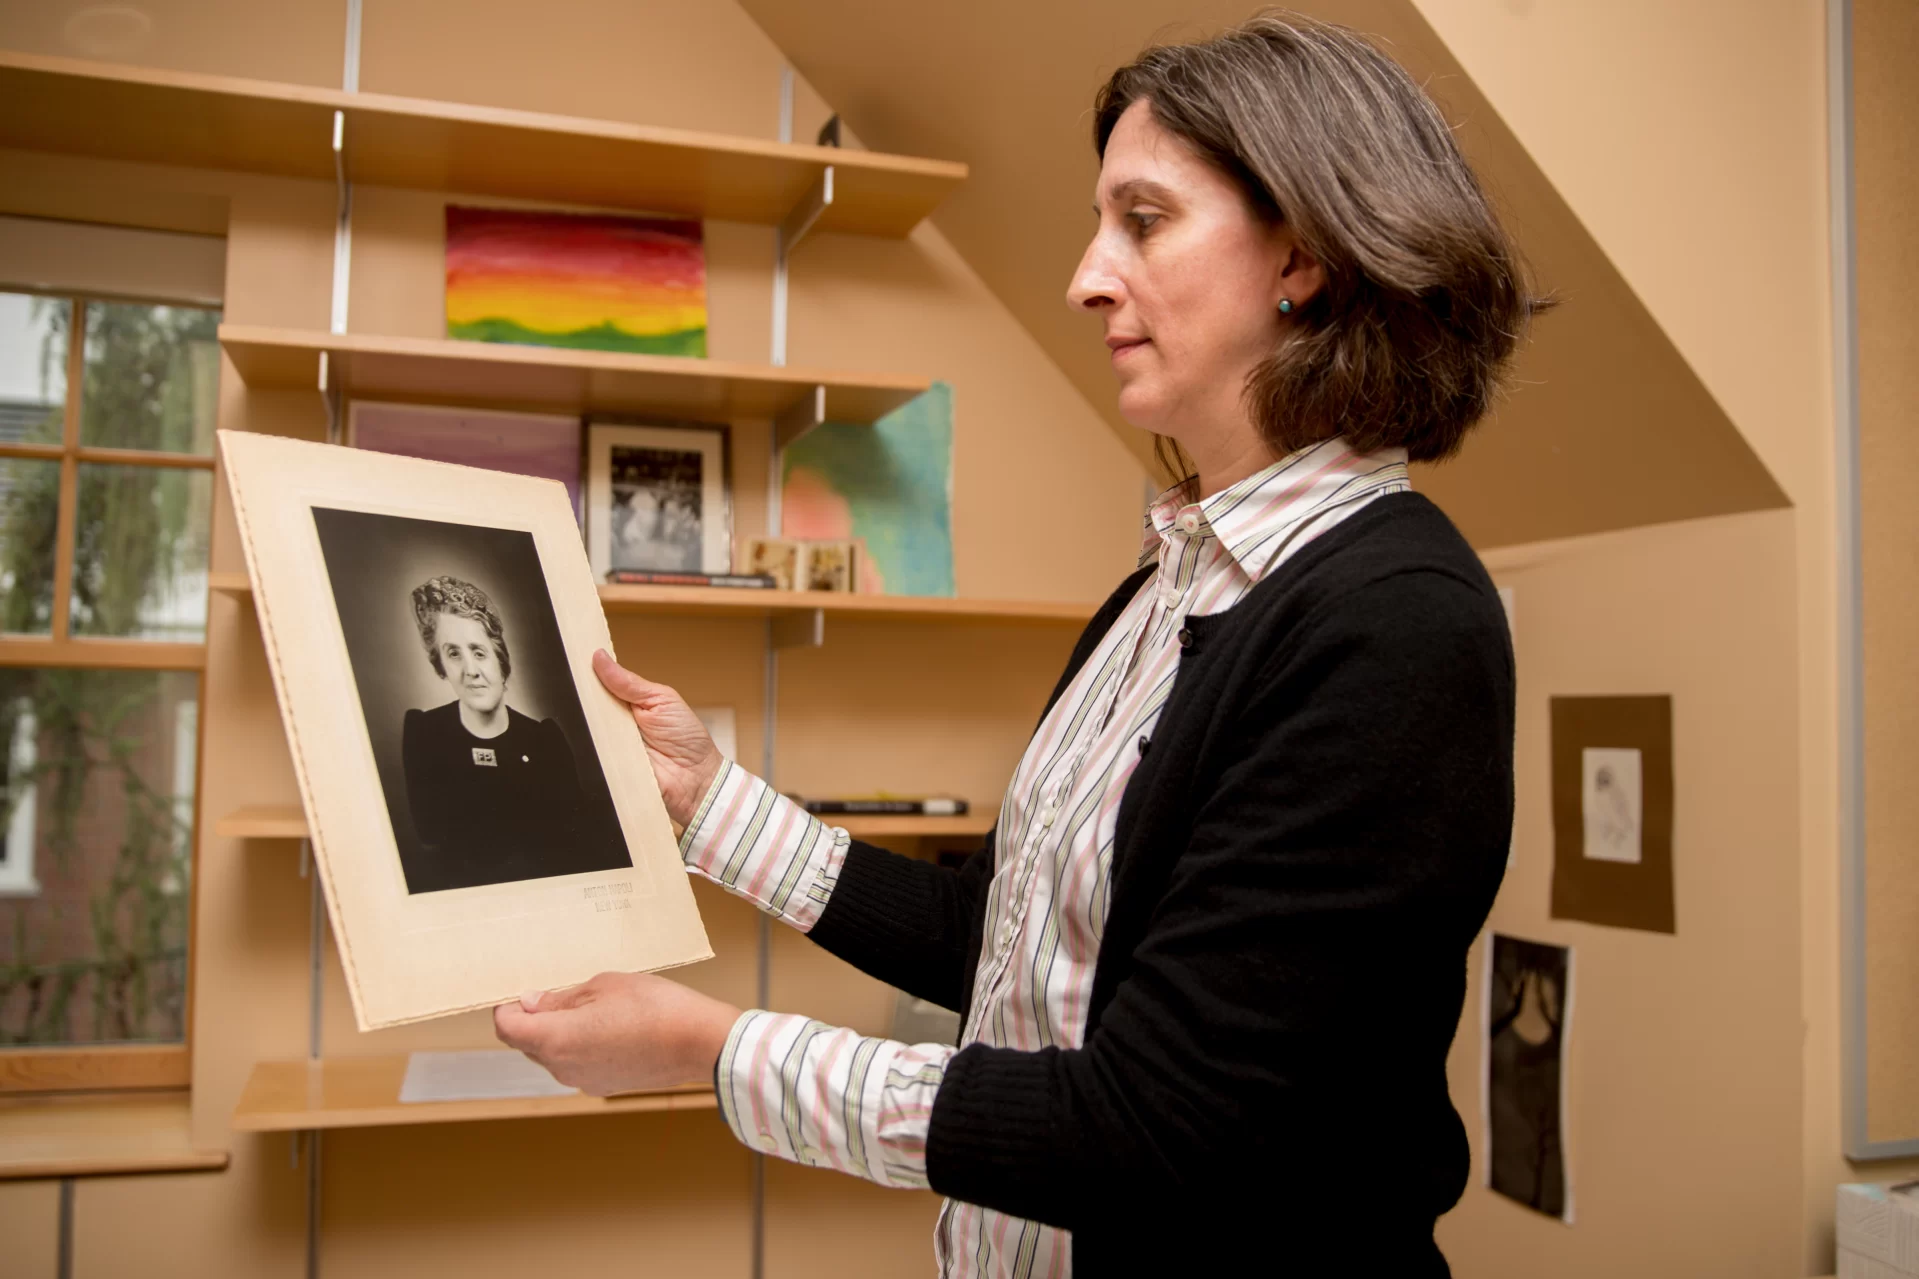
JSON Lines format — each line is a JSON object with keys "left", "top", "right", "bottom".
{"left": 0, "top": 0, "right": 1140, "bottom": 1279}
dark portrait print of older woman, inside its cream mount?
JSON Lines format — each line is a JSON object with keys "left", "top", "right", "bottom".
{"left": 313, "top": 507, "right": 633, "bottom": 893}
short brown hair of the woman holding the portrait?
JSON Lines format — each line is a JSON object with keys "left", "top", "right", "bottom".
{"left": 1094, "top": 10, "right": 1543, "bottom": 461}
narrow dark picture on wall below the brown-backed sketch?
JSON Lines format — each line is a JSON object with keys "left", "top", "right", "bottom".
{"left": 1483, "top": 933, "right": 1572, "bottom": 1221}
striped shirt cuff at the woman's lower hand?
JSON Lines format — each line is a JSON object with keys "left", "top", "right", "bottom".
{"left": 714, "top": 1008, "right": 958, "bottom": 1191}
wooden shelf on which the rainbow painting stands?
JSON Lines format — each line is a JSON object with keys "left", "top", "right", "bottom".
{"left": 221, "top": 325, "right": 933, "bottom": 424}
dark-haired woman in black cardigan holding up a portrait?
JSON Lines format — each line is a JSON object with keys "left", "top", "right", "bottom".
{"left": 495, "top": 13, "right": 1537, "bottom": 1275}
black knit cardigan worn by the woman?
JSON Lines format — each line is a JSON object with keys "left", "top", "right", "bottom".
{"left": 810, "top": 494, "right": 1514, "bottom": 1277}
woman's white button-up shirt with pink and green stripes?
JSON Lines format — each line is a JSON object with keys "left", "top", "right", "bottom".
{"left": 681, "top": 440, "right": 1409, "bottom": 1277}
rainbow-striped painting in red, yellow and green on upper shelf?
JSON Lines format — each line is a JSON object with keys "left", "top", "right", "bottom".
{"left": 447, "top": 204, "right": 706, "bottom": 357}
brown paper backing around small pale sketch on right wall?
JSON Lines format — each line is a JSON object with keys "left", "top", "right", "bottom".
{"left": 1551, "top": 695, "right": 1675, "bottom": 933}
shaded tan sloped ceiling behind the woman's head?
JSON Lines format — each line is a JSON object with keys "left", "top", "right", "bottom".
{"left": 741, "top": 0, "right": 1789, "bottom": 547}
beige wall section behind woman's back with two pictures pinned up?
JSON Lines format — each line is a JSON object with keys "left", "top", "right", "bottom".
{"left": 1439, "top": 511, "right": 1802, "bottom": 1279}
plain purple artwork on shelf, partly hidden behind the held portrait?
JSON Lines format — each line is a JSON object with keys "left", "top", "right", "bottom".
{"left": 349, "top": 401, "right": 581, "bottom": 519}
